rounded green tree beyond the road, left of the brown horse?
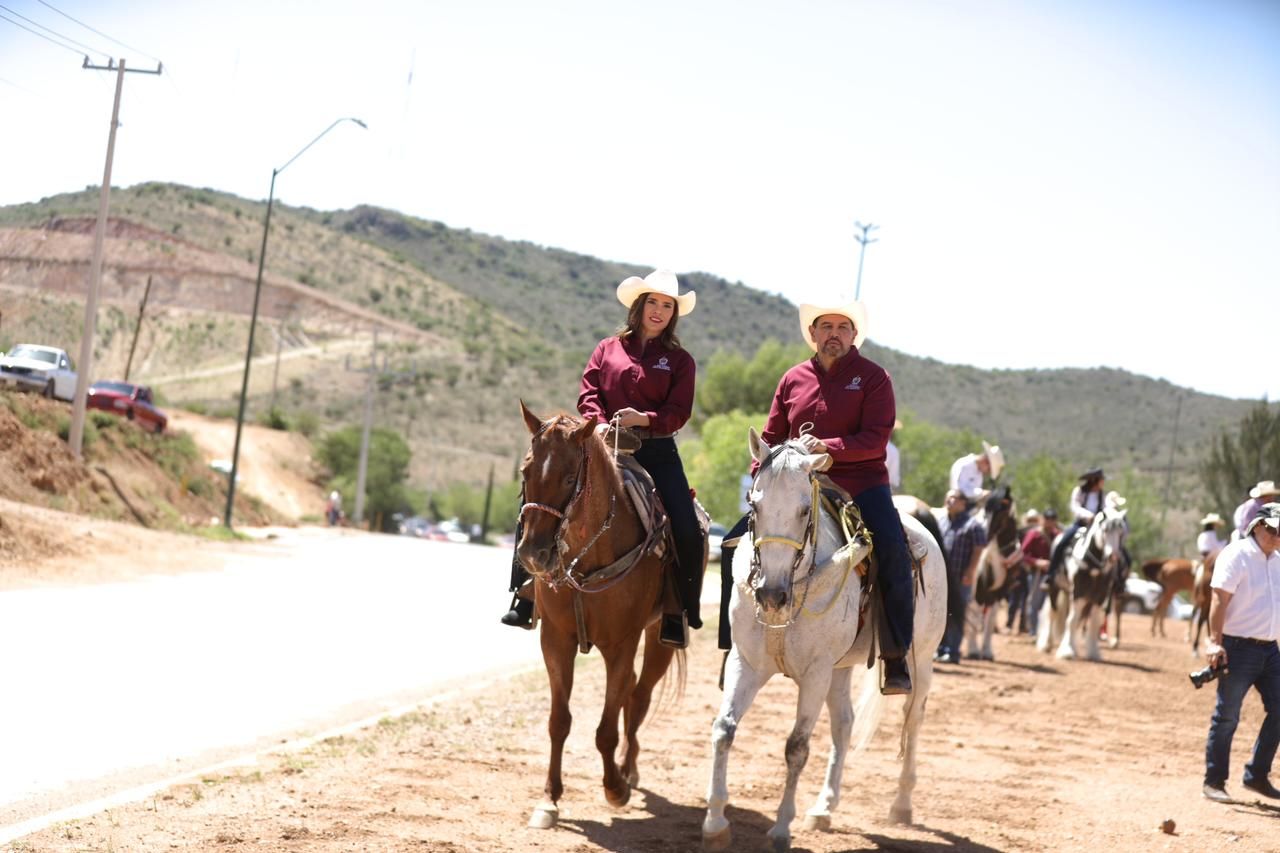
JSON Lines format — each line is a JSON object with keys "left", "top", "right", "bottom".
{"left": 317, "top": 427, "right": 416, "bottom": 530}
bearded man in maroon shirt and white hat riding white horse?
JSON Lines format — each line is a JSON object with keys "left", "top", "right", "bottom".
{"left": 719, "top": 295, "right": 915, "bottom": 694}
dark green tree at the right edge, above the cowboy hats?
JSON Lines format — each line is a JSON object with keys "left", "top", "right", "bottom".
{"left": 1199, "top": 400, "right": 1280, "bottom": 519}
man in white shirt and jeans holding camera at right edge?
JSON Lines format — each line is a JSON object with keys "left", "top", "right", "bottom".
{"left": 1203, "top": 503, "right": 1280, "bottom": 803}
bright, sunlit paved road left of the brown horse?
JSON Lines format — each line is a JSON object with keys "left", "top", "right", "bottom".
{"left": 0, "top": 529, "right": 541, "bottom": 833}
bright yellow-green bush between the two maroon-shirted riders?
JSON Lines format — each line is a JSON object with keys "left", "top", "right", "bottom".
{"left": 681, "top": 411, "right": 765, "bottom": 525}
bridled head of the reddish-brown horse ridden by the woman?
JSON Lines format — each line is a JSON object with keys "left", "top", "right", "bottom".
{"left": 516, "top": 401, "right": 599, "bottom": 575}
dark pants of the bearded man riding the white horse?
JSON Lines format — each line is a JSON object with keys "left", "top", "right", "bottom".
{"left": 719, "top": 485, "right": 915, "bottom": 658}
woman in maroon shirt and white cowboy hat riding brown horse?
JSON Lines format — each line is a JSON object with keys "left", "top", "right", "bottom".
{"left": 502, "top": 270, "right": 704, "bottom": 648}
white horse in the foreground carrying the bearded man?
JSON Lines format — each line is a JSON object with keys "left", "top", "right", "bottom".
{"left": 703, "top": 429, "right": 947, "bottom": 850}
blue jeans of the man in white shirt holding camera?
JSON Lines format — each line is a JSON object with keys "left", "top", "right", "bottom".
{"left": 1204, "top": 635, "right": 1280, "bottom": 786}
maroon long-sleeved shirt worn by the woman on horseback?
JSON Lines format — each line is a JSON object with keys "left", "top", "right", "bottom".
{"left": 577, "top": 336, "right": 698, "bottom": 435}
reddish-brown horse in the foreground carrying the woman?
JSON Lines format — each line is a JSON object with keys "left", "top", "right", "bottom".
{"left": 517, "top": 402, "right": 685, "bottom": 829}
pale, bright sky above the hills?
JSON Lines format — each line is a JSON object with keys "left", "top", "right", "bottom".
{"left": 0, "top": 0, "right": 1280, "bottom": 405}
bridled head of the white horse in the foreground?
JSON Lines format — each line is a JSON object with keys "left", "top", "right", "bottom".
{"left": 748, "top": 429, "right": 870, "bottom": 622}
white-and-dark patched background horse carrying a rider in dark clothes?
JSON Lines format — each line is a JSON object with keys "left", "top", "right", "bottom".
{"left": 1036, "top": 507, "right": 1126, "bottom": 661}
